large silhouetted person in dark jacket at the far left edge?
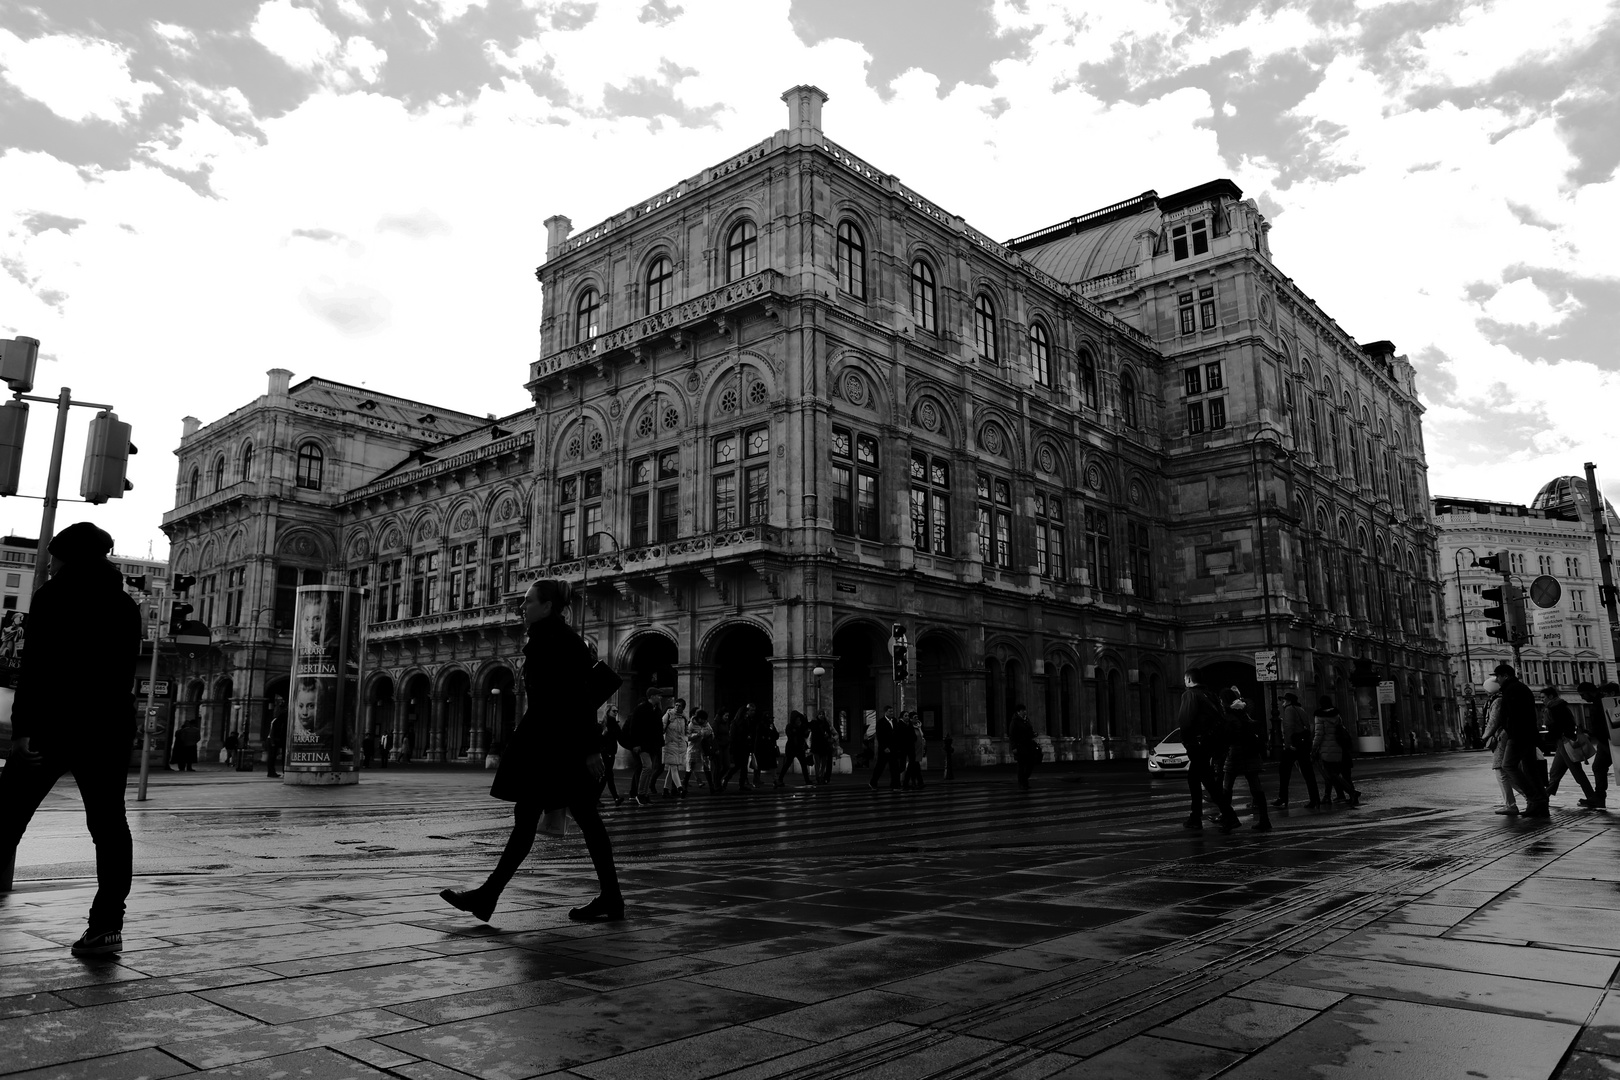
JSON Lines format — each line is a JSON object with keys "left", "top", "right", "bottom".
{"left": 0, "top": 521, "right": 141, "bottom": 957}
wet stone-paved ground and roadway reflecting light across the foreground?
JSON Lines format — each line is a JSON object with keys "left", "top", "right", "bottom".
{"left": 0, "top": 755, "right": 1620, "bottom": 1080}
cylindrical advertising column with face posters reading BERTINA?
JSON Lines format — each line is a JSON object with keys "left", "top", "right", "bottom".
{"left": 284, "top": 585, "right": 365, "bottom": 784}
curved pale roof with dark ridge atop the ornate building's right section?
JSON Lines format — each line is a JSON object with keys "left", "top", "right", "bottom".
{"left": 1006, "top": 180, "right": 1243, "bottom": 285}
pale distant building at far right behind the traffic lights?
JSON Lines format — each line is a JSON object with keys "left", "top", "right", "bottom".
{"left": 1434, "top": 476, "right": 1620, "bottom": 725}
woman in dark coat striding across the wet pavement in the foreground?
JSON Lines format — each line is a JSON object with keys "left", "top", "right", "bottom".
{"left": 439, "top": 578, "right": 624, "bottom": 921}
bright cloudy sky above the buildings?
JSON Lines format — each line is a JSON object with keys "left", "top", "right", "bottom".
{"left": 0, "top": 0, "right": 1620, "bottom": 554}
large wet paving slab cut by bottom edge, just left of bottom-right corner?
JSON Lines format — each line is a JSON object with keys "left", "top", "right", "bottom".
{"left": 1221, "top": 997, "right": 1576, "bottom": 1080}
